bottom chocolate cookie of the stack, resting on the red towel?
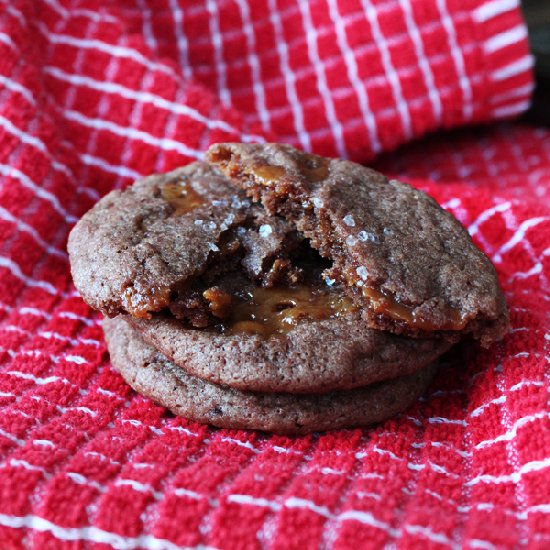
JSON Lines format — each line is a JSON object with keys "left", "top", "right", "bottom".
{"left": 103, "top": 317, "right": 435, "bottom": 434}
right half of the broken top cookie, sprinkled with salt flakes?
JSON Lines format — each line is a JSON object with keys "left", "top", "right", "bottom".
{"left": 207, "top": 143, "right": 508, "bottom": 346}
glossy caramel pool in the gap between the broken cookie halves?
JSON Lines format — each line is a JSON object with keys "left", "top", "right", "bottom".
{"left": 223, "top": 286, "right": 357, "bottom": 337}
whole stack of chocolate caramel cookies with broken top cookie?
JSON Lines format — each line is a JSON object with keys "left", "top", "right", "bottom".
{"left": 69, "top": 144, "right": 508, "bottom": 433}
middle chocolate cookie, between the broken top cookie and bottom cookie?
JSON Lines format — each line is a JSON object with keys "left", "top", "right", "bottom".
{"left": 132, "top": 312, "right": 452, "bottom": 393}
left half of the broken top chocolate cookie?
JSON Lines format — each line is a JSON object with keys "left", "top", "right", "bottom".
{"left": 68, "top": 163, "right": 254, "bottom": 323}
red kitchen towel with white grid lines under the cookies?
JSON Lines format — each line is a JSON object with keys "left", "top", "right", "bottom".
{"left": 0, "top": 0, "right": 550, "bottom": 550}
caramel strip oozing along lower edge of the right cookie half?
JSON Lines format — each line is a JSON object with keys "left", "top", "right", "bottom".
{"left": 363, "top": 286, "right": 467, "bottom": 332}
